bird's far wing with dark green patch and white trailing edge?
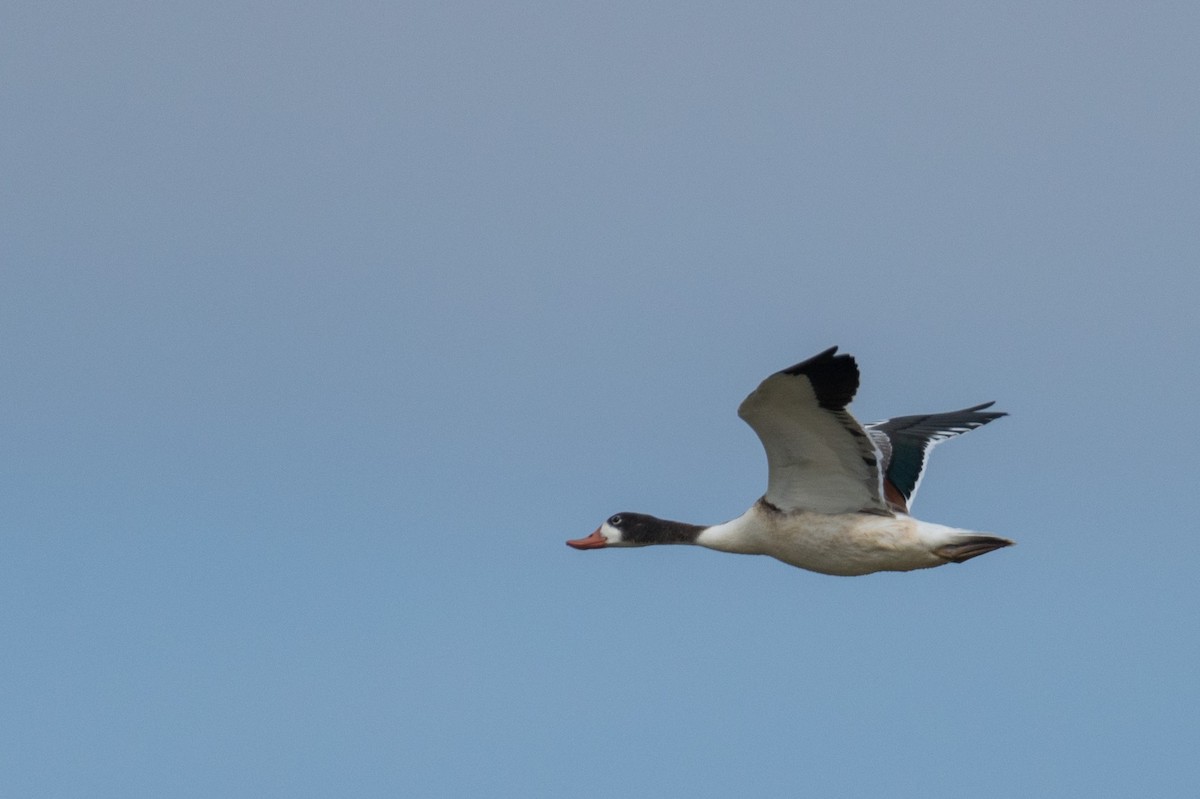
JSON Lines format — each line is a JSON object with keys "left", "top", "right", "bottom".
{"left": 866, "top": 402, "right": 1008, "bottom": 512}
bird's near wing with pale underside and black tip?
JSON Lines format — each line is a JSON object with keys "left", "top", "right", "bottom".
{"left": 738, "top": 347, "right": 890, "bottom": 513}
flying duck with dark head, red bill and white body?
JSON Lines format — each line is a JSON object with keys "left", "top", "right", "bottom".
{"left": 566, "top": 347, "right": 1013, "bottom": 576}
